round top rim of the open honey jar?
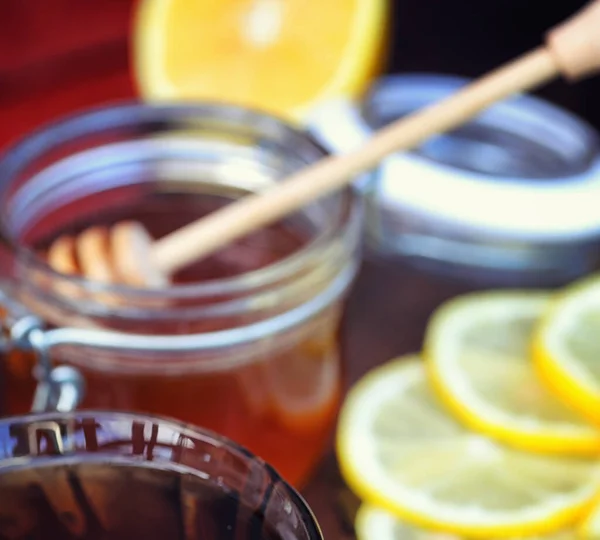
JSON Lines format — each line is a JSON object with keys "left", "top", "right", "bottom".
{"left": 0, "top": 100, "right": 359, "bottom": 300}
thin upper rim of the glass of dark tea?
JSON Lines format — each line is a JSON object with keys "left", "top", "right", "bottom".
{"left": 0, "top": 409, "right": 322, "bottom": 540}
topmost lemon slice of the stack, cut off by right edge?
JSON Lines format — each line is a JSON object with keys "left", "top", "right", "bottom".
{"left": 533, "top": 276, "right": 600, "bottom": 424}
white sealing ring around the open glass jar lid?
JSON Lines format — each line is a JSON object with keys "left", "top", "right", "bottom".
{"left": 308, "top": 94, "right": 600, "bottom": 242}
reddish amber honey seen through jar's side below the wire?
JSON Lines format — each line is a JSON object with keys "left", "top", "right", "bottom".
{"left": 6, "top": 334, "right": 341, "bottom": 486}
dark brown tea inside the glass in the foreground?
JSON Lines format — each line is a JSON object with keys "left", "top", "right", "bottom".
{"left": 0, "top": 463, "right": 284, "bottom": 540}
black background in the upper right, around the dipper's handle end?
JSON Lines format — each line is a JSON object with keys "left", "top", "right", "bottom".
{"left": 389, "top": 0, "right": 600, "bottom": 128}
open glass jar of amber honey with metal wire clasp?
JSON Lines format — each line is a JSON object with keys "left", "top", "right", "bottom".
{"left": 0, "top": 100, "right": 361, "bottom": 484}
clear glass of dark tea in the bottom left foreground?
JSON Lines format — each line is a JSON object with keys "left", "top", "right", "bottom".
{"left": 0, "top": 412, "right": 322, "bottom": 540}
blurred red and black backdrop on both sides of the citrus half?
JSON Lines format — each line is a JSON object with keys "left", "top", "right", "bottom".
{"left": 0, "top": 0, "right": 600, "bottom": 146}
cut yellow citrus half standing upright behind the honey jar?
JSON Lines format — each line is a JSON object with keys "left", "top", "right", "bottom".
{"left": 134, "top": 0, "right": 387, "bottom": 119}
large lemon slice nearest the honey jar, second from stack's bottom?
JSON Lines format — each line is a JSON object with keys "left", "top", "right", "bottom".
{"left": 337, "top": 357, "right": 600, "bottom": 538}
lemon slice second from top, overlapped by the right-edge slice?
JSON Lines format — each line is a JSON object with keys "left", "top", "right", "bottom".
{"left": 424, "top": 291, "right": 600, "bottom": 455}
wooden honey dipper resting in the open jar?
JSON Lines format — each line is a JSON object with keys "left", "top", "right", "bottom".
{"left": 48, "top": 0, "right": 600, "bottom": 288}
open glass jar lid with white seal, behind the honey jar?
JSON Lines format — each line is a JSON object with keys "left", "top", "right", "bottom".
{"left": 310, "top": 75, "right": 600, "bottom": 282}
